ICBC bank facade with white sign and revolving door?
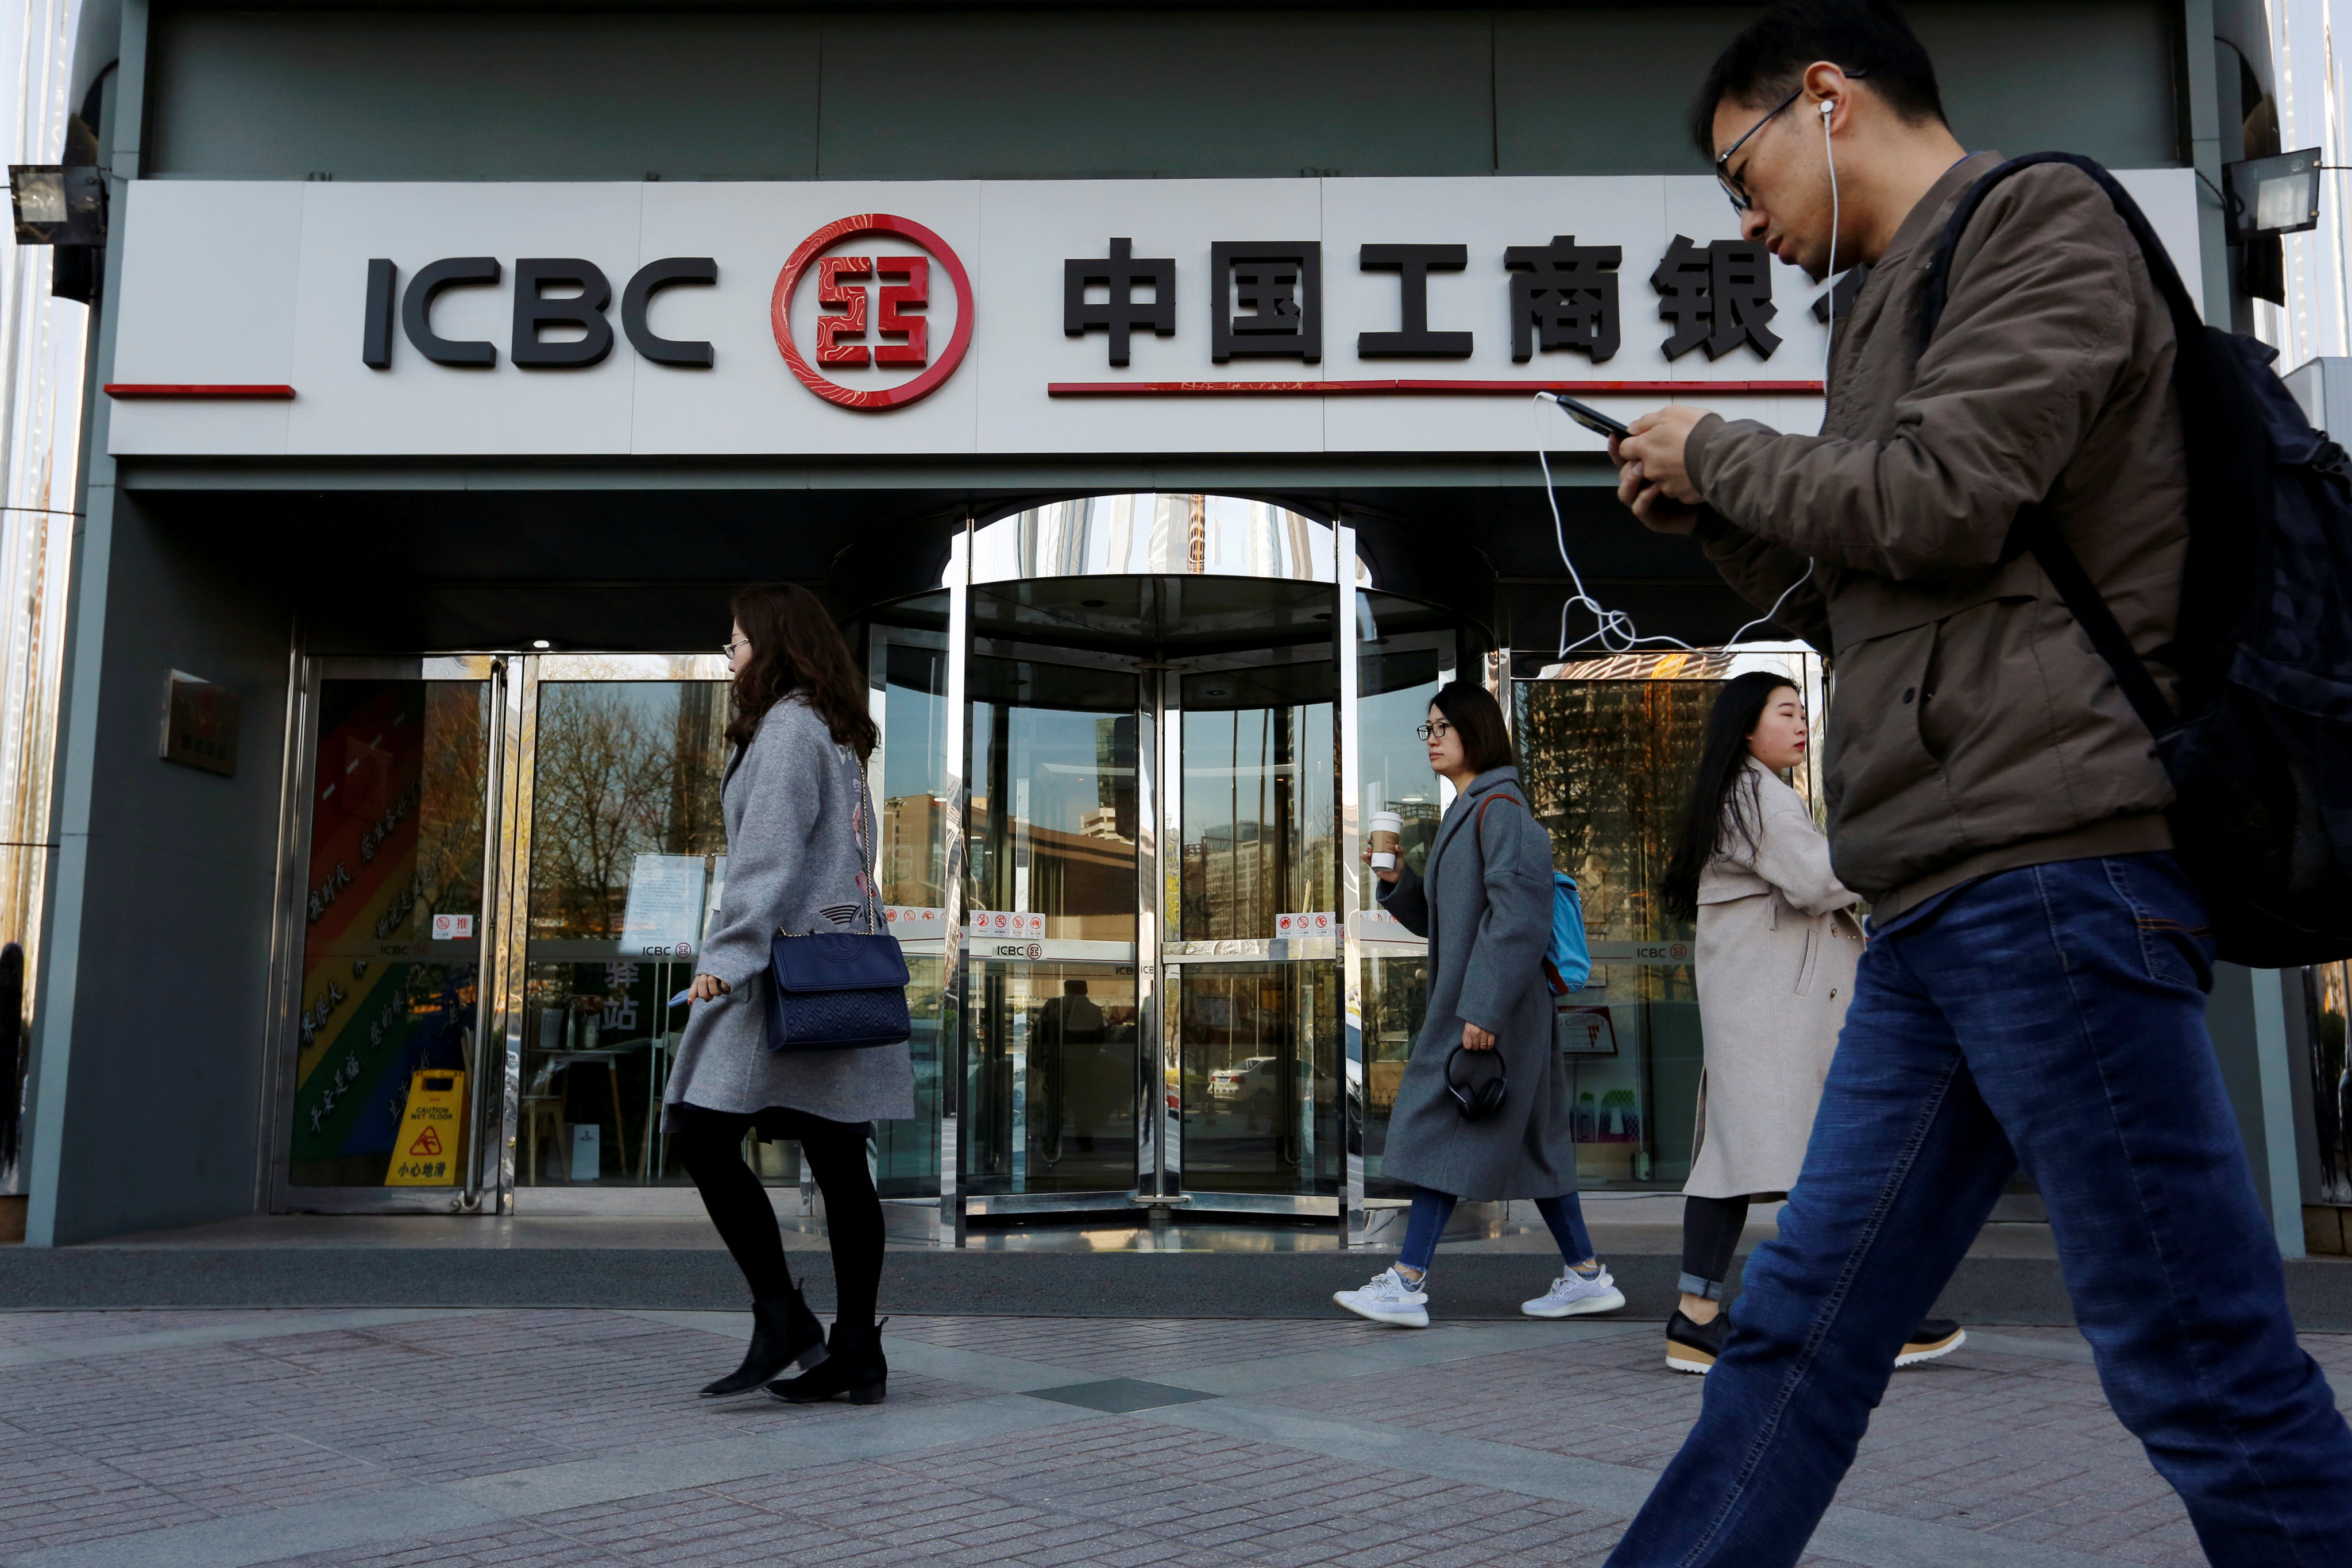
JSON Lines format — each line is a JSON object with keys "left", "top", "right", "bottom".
{"left": 9, "top": 0, "right": 2309, "bottom": 1250}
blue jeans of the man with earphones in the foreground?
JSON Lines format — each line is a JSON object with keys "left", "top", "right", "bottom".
{"left": 1609, "top": 856, "right": 2352, "bottom": 1568}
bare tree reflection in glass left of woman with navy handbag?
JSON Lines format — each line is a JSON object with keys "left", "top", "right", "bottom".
{"left": 531, "top": 682, "right": 727, "bottom": 938}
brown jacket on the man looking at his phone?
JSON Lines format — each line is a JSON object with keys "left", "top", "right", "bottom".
{"left": 1689, "top": 153, "right": 2187, "bottom": 917}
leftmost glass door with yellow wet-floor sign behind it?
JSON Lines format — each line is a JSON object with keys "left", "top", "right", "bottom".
{"left": 271, "top": 656, "right": 505, "bottom": 1213}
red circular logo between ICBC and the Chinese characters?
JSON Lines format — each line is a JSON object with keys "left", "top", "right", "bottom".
{"left": 767, "top": 211, "right": 971, "bottom": 409}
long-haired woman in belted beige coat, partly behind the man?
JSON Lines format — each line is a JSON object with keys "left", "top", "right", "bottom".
{"left": 1663, "top": 670, "right": 1961, "bottom": 1373}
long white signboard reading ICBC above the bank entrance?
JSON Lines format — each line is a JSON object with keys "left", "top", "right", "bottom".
{"left": 108, "top": 169, "right": 2199, "bottom": 456}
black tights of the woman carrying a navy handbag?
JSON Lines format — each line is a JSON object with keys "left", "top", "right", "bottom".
{"left": 668, "top": 1105, "right": 882, "bottom": 1328}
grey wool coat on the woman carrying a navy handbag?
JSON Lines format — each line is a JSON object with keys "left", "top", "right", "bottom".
{"left": 663, "top": 696, "right": 915, "bottom": 1121}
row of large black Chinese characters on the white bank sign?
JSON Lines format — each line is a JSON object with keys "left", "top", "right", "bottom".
{"left": 1058, "top": 235, "right": 1781, "bottom": 367}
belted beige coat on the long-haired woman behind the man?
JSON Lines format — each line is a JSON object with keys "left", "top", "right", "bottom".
{"left": 1682, "top": 759, "right": 1863, "bottom": 1199}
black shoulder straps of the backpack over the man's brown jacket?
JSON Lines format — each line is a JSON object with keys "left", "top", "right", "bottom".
{"left": 1920, "top": 153, "right": 2204, "bottom": 736}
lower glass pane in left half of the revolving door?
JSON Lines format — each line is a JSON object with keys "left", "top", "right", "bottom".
{"left": 969, "top": 961, "right": 1138, "bottom": 1194}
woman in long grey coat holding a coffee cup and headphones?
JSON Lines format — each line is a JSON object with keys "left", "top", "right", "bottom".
{"left": 1331, "top": 682, "right": 1625, "bottom": 1328}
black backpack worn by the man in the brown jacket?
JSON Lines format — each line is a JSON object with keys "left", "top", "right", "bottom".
{"left": 1920, "top": 153, "right": 2352, "bottom": 968}
